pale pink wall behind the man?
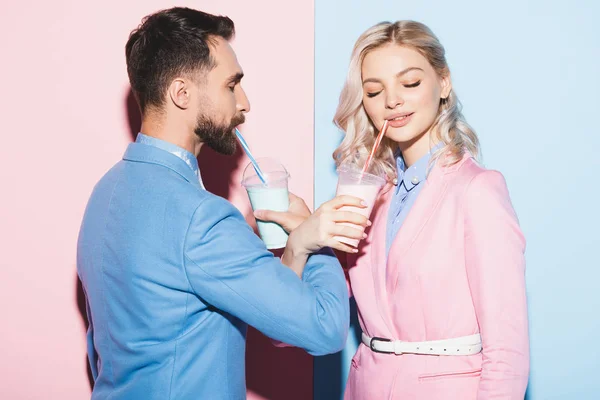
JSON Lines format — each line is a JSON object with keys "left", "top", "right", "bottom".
{"left": 0, "top": 0, "right": 314, "bottom": 400}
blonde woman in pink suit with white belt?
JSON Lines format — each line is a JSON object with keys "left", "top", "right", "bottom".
{"left": 334, "top": 21, "right": 529, "bottom": 400}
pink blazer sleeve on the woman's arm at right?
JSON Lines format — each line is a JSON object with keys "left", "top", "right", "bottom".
{"left": 464, "top": 171, "right": 529, "bottom": 400}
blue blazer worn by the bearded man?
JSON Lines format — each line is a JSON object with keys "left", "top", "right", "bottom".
{"left": 77, "top": 143, "right": 349, "bottom": 400}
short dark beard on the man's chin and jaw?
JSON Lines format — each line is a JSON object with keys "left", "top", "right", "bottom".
{"left": 194, "top": 114, "right": 246, "bottom": 156}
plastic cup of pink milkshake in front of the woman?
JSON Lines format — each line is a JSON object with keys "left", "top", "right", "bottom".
{"left": 335, "top": 164, "right": 386, "bottom": 247}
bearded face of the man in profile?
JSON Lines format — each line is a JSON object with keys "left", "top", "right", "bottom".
{"left": 194, "top": 38, "right": 250, "bottom": 155}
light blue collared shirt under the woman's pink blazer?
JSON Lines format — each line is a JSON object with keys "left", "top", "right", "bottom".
{"left": 385, "top": 143, "right": 442, "bottom": 257}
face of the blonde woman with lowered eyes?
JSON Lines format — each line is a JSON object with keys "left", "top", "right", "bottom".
{"left": 362, "top": 44, "right": 451, "bottom": 151}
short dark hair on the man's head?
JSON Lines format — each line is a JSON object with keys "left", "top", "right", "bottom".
{"left": 125, "top": 7, "right": 235, "bottom": 114}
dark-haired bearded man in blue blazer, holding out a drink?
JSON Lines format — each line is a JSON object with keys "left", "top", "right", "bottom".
{"left": 77, "top": 8, "right": 367, "bottom": 400}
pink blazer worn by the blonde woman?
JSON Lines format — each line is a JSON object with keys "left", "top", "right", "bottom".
{"left": 345, "top": 156, "right": 529, "bottom": 400}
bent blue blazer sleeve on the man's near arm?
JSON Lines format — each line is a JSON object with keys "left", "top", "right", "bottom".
{"left": 184, "top": 197, "right": 349, "bottom": 355}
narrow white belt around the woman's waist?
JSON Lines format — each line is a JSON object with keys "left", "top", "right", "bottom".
{"left": 362, "top": 332, "right": 481, "bottom": 356}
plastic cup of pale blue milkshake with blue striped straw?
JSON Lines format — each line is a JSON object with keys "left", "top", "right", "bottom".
{"left": 242, "top": 158, "right": 290, "bottom": 249}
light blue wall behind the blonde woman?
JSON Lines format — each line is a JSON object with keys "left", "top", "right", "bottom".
{"left": 315, "top": 0, "right": 600, "bottom": 400}
